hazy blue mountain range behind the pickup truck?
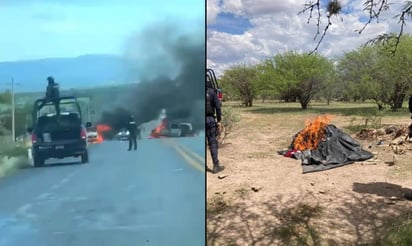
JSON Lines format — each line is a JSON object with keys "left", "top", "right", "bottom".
{"left": 0, "top": 54, "right": 136, "bottom": 92}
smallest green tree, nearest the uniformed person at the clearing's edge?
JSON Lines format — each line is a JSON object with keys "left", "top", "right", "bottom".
{"left": 220, "top": 65, "right": 256, "bottom": 107}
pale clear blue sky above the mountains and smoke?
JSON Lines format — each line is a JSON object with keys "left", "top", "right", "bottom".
{"left": 0, "top": 0, "right": 205, "bottom": 61}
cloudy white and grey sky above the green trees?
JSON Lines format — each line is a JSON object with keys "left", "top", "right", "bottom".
{"left": 207, "top": 0, "right": 412, "bottom": 74}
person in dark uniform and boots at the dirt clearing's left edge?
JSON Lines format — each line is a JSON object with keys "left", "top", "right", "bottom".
{"left": 206, "top": 76, "right": 224, "bottom": 173}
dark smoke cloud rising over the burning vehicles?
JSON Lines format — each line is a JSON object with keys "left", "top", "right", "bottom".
{"left": 101, "top": 22, "right": 206, "bottom": 133}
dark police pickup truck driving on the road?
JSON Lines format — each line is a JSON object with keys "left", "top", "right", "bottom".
{"left": 27, "top": 97, "right": 91, "bottom": 167}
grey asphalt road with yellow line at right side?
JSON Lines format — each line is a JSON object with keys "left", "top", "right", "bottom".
{"left": 0, "top": 136, "right": 205, "bottom": 246}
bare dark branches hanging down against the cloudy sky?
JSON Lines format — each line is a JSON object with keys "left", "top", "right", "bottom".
{"left": 299, "top": 0, "right": 412, "bottom": 54}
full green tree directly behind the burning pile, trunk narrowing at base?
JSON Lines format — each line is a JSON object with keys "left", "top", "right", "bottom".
{"left": 274, "top": 51, "right": 334, "bottom": 109}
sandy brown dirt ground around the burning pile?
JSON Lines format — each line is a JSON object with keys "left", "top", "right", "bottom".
{"left": 207, "top": 111, "right": 412, "bottom": 245}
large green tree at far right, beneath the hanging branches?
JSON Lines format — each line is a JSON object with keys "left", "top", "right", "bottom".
{"left": 338, "top": 35, "right": 412, "bottom": 111}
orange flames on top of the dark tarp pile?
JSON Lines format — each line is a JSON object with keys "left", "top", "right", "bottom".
{"left": 293, "top": 115, "right": 332, "bottom": 151}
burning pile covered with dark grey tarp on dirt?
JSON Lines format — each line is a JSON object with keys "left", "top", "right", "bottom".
{"left": 279, "top": 116, "right": 373, "bottom": 173}
